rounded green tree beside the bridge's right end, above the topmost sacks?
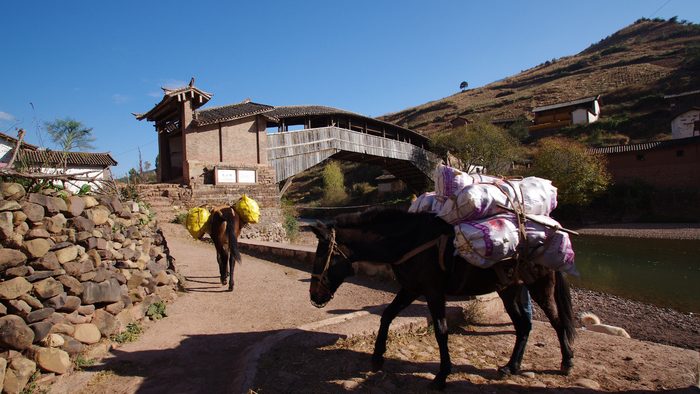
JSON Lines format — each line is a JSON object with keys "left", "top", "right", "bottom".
{"left": 431, "top": 119, "right": 523, "bottom": 175}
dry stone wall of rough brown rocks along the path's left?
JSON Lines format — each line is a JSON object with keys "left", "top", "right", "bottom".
{"left": 0, "top": 183, "right": 179, "bottom": 393}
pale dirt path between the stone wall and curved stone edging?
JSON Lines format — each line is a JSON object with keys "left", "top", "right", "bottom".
{"left": 52, "top": 224, "right": 400, "bottom": 394}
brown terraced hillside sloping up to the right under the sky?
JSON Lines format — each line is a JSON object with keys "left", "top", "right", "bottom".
{"left": 379, "top": 18, "right": 700, "bottom": 142}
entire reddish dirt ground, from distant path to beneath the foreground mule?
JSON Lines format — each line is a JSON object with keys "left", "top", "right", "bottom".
{"left": 51, "top": 224, "right": 700, "bottom": 394}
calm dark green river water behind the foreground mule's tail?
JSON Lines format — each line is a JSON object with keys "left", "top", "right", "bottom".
{"left": 569, "top": 235, "right": 700, "bottom": 314}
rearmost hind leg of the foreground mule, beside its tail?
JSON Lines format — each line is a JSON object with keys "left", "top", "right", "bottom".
{"left": 529, "top": 272, "right": 576, "bottom": 375}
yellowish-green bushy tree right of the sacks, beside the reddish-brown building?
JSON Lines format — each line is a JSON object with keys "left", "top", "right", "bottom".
{"left": 532, "top": 138, "right": 611, "bottom": 206}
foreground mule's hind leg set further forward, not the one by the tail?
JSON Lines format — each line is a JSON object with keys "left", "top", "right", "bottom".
{"left": 498, "top": 286, "right": 532, "bottom": 375}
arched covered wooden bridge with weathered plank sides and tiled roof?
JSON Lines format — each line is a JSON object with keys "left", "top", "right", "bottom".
{"left": 265, "top": 106, "right": 441, "bottom": 192}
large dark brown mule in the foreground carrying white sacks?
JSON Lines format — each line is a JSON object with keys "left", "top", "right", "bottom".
{"left": 310, "top": 209, "right": 575, "bottom": 390}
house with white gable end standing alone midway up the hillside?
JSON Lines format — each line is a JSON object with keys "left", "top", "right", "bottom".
{"left": 530, "top": 95, "right": 600, "bottom": 131}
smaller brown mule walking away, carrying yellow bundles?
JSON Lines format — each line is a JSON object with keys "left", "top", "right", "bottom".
{"left": 209, "top": 207, "right": 245, "bottom": 291}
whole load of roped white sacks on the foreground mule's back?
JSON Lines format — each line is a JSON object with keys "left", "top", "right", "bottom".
{"left": 409, "top": 166, "right": 578, "bottom": 275}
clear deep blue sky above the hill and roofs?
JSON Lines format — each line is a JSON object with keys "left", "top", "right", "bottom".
{"left": 0, "top": 0, "right": 700, "bottom": 176}
